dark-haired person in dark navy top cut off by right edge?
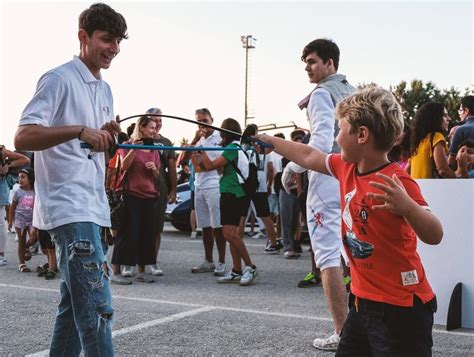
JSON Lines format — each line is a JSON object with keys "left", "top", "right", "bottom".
{"left": 448, "top": 95, "right": 474, "bottom": 167}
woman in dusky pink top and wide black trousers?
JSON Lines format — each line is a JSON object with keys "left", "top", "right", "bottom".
{"left": 112, "top": 116, "right": 160, "bottom": 284}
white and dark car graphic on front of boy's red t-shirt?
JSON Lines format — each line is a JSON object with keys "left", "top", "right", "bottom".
{"left": 342, "top": 189, "right": 374, "bottom": 259}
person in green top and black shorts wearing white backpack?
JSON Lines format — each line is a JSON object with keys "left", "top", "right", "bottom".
{"left": 197, "top": 118, "right": 257, "bottom": 285}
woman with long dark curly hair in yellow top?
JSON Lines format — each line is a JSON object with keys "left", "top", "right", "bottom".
{"left": 407, "top": 102, "right": 455, "bottom": 179}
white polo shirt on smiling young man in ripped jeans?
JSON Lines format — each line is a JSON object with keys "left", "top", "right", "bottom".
{"left": 19, "top": 56, "right": 114, "bottom": 230}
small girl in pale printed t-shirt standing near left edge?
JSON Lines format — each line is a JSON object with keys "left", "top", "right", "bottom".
{"left": 9, "top": 169, "right": 35, "bottom": 273}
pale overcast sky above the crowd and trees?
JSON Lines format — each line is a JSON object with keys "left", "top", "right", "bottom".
{"left": 0, "top": 1, "right": 474, "bottom": 148}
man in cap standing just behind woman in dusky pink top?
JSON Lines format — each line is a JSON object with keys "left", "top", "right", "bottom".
{"left": 146, "top": 108, "right": 178, "bottom": 276}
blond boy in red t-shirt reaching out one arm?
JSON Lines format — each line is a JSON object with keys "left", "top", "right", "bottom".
{"left": 257, "top": 87, "right": 443, "bottom": 356}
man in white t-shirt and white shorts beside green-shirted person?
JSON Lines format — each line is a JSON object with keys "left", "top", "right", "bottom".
{"left": 184, "top": 108, "right": 226, "bottom": 276}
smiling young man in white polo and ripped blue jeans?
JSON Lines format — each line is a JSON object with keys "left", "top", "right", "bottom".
{"left": 15, "top": 4, "right": 127, "bottom": 356}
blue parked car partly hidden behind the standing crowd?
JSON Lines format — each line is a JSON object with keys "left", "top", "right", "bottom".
{"left": 165, "top": 182, "right": 191, "bottom": 232}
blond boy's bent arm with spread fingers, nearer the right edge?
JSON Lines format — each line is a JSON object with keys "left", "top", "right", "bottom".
{"left": 367, "top": 173, "right": 443, "bottom": 245}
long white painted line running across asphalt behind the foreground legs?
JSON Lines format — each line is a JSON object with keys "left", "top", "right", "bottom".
{"left": 0, "top": 283, "right": 474, "bottom": 337}
